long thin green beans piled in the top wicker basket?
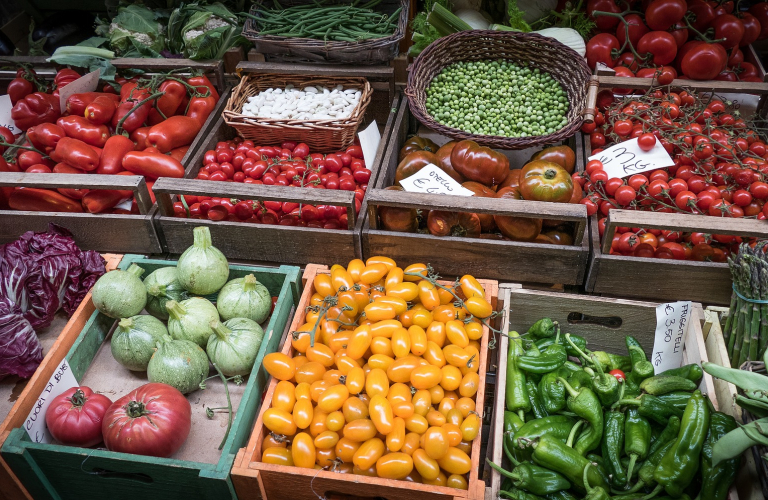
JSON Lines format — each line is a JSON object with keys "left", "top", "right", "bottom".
{"left": 250, "top": 0, "right": 401, "bottom": 42}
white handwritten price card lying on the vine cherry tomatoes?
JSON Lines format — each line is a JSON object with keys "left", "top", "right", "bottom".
{"left": 588, "top": 139, "right": 675, "bottom": 179}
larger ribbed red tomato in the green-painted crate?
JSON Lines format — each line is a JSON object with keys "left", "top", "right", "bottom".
{"left": 102, "top": 383, "right": 192, "bottom": 457}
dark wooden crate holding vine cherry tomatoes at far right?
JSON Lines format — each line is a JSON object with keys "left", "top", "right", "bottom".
{"left": 583, "top": 76, "right": 768, "bottom": 305}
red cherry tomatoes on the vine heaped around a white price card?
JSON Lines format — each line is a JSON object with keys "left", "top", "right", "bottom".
{"left": 574, "top": 90, "right": 768, "bottom": 262}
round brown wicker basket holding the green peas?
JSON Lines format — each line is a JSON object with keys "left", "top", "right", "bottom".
{"left": 406, "top": 30, "right": 590, "bottom": 149}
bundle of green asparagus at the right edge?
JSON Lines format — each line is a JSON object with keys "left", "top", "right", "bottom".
{"left": 723, "top": 242, "right": 768, "bottom": 367}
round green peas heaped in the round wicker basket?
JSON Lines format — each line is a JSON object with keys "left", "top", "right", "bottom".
{"left": 426, "top": 59, "right": 568, "bottom": 137}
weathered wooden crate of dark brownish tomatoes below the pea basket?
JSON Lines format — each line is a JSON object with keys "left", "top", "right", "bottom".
{"left": 362, "top": 91, "right": 589, "bottom": 285}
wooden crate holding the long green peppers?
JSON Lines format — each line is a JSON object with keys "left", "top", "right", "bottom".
{"left": 486, "top": 283, "right": 724, "bottom": 500}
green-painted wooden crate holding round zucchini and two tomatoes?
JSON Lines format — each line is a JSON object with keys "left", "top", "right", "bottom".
{"left": 1, "top": 255, "right": 299, "bottom": 499}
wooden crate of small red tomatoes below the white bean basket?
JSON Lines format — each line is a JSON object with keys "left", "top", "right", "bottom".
{"left": 153, "top": 63, "right": 397, "bottom": 265}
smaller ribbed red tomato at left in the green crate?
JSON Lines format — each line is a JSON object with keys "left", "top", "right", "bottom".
{"left": 45, "top": 387, "right": 112, "bottom": 448}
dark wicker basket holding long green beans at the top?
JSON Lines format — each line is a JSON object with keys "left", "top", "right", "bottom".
{"left": 243, "top": 0, "right": 409, "bottom": 64}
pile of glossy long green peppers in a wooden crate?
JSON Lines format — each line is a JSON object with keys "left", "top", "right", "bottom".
{"left": 496, "top": 318, "right": 738, "bottom": 500}
